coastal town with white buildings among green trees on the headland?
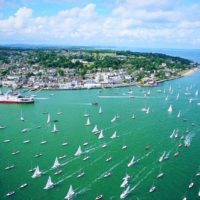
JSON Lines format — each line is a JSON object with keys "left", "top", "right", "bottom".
{"left": 0, "top": 48, "right": 198, "bottom": 89}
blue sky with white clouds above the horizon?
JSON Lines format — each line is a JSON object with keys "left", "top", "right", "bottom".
{"left": 0, "top": 0, "right": 200, "bottom": 49}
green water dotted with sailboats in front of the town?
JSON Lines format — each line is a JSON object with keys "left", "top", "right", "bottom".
{"left": 0, "top": 73, "right": 200, "bottom": 200}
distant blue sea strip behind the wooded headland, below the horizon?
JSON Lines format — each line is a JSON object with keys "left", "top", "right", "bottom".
{"left": 112, "top": 47, "right": 200, "bottom": 63}
